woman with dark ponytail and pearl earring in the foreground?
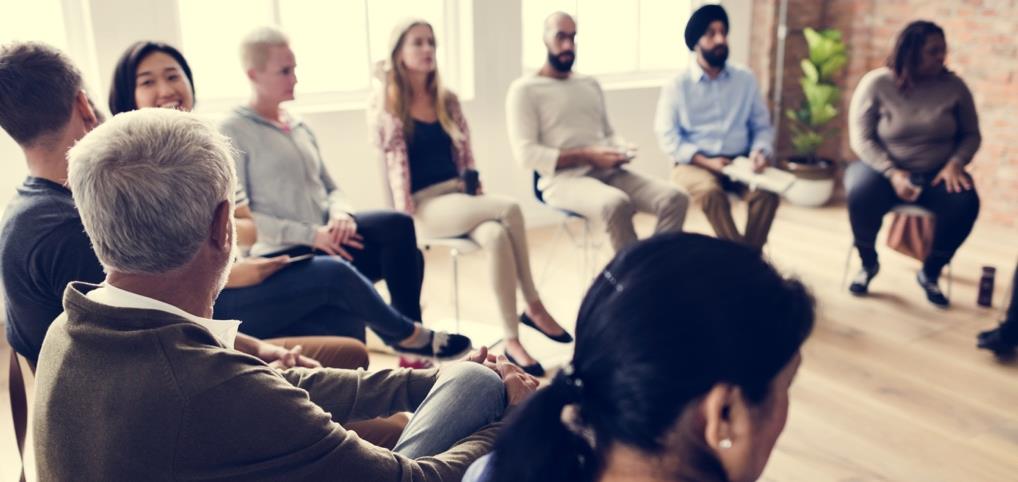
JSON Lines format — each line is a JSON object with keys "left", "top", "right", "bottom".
{"left": 463, "top": 233, "right": 813, "bottom": 482}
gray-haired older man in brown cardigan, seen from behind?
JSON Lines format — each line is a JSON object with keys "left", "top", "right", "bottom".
{"left": 35, "top": 109, "right": 535, "bottom": 481}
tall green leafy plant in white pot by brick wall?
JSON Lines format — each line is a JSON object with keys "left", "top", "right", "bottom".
{"left": 782, "top": 28, "right": 848, "bottom": 206}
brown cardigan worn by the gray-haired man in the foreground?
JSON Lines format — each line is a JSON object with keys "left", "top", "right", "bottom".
{"left": 34, "top": 283, "right": 498, "bottom": 482}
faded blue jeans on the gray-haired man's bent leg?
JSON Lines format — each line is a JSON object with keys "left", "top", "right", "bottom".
{"left": 393, "top": 362, "right": 506, "bottom": 459}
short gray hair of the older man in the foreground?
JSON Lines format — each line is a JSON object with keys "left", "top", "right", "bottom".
{"left": 68, "top": 109, "right": 236, "bottom": 274}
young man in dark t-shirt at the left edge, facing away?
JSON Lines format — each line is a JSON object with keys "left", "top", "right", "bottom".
{"left": 0, "top": 43, "right": 105, "bottom": 365}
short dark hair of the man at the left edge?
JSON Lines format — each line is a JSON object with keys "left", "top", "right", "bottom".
{"left": 0, "top": 42, "right": 82, "bottom": 146}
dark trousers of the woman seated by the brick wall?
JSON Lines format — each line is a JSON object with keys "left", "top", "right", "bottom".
{"left": 845, "top": 161, "right": 979, "bottom": 279}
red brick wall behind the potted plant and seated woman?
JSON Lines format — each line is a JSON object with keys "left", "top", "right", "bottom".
{"left": 750, "top": 0, "right": 1018, "bottom": 226}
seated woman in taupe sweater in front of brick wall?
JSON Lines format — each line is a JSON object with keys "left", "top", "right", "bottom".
{"left": 845, "top": 20, "right": 981, "bottom": 307}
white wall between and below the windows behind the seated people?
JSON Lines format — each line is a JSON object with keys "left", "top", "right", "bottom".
{"left": 0, "top": 0, "right": 751, "bottom": 224}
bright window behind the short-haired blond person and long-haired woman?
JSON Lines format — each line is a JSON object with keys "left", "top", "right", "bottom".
{"left": 178, "top": 0, "right": 472, "bottom": 108}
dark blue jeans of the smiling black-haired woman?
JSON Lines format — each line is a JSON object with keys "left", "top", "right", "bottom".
{"left": 213, "top": 256, "right": 413, "bottom": 344}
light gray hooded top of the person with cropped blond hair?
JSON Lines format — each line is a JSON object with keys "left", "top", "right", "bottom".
{"left": 220, "top": 107, "right": 353, "bottom": 255}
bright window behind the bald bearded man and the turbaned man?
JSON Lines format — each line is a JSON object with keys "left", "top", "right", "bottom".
{"left": 522, "top": 0, "right": 692, "bottom": 76}
